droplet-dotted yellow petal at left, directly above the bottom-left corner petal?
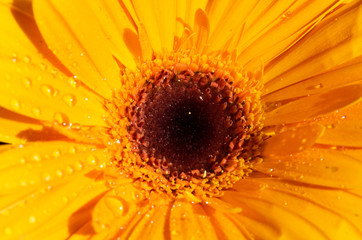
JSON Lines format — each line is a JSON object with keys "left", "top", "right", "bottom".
{"left": 0, "top": 141, "right": 106, "bottom": 194}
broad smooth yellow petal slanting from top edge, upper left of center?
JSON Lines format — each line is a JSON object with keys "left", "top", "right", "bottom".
{"left": 33, "top": 1, "right": 125, "bottom": 97}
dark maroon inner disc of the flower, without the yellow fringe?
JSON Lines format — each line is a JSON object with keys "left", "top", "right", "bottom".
{"left": 129, "top": 70, "right": 245, "bottom": 179}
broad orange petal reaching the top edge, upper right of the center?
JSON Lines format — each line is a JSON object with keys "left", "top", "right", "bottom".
{"left": 238, "top": 0, "right": 341, "bottom": 71}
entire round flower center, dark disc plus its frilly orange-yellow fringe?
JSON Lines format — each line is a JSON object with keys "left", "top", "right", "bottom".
{"left": 108, "top": 53, "right": 263, "bottom": 197}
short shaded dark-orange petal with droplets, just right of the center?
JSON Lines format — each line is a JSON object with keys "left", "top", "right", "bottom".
{"left": 262, "top": 124, "right": 325, "bottom": 157}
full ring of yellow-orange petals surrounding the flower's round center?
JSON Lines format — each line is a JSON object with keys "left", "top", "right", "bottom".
{"left": 0, "top": 0, "right": 362, "bottom": 239}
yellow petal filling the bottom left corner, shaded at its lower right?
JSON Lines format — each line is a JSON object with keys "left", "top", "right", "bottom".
{"left": 0, "top": 172, "right": 107, "bottom": 239}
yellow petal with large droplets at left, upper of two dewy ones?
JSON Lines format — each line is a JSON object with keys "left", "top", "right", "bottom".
{"left": 0, "top": 58, "right": 105, "bottom": 126}
